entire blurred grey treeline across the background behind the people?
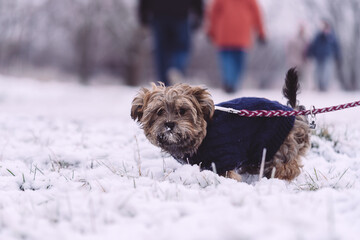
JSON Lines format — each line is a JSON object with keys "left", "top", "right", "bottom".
{"left": 0, "top": 0, "right": 360, "bottom": 90}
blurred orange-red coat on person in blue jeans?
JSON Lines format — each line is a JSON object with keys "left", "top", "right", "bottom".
{"left": 207, "top": 0, "right": 265, "bottom": 48}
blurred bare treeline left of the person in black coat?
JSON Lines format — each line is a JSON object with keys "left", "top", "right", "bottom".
{"left": 0, "top": 0, "right": 141, "bottom": 83}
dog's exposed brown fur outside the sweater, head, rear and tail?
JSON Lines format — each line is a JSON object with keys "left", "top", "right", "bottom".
{"left": 131, "top": 70, "right": 310, "bottom": 181}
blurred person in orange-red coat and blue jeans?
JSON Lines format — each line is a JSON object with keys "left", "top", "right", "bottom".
{"left": 207, "top": 0, "right": 266, "bottom": 93}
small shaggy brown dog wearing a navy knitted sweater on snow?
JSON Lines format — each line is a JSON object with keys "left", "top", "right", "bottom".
{"left": 131, "top": 69, "right": 310, "bottom": 180}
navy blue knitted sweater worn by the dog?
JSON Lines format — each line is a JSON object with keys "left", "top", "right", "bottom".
{"left": 188, "top": 98, "right": 295, "bottom": 174}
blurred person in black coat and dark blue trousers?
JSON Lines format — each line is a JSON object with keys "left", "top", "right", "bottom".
{"left": 138, "top": 0, "right": 203, "bottom": 85}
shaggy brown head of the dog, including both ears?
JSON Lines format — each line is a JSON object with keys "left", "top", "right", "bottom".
{"left": 131, "top": 84, "right": 214, "bottom": 158}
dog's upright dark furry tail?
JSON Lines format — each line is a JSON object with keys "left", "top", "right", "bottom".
{"left": 283, "top": 68, "right": 300, "bottom": 108}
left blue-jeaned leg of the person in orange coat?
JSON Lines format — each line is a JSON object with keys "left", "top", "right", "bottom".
{"left": 219, "top": 49, "right": 237, "bottom": 93}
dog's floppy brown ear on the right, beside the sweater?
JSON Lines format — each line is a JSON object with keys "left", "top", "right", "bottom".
{"left": 191, "top": 87, "right": 215, "bottom": 121}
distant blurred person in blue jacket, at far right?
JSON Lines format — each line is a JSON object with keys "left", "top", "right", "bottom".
{"left": 307, "top": 20, "right": 341, "bottom": 91}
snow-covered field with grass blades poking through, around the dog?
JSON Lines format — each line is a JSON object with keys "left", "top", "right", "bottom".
{"left": 0, "top": 77, "right": 360, "bottom": 240}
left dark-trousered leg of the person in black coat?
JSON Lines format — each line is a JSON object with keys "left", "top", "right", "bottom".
{"left": 152, "top": 20, "right": 170, "bottom": 85}
